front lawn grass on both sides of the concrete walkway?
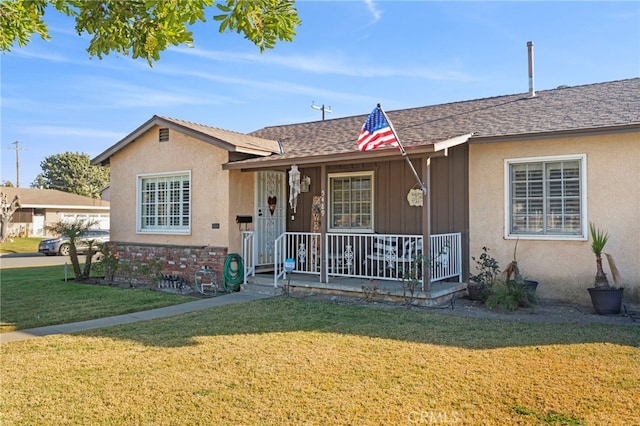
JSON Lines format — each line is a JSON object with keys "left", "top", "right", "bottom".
{"left": 0, "top": 268, "right": 640, "bottom": 425}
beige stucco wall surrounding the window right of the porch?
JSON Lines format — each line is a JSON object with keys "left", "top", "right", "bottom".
{"left": 469, "top": 133, "right": 640, "bottom": 304}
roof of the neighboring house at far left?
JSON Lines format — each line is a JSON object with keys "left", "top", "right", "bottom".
{"left": 0, "top": 186, "right": 109, "bottom": 210}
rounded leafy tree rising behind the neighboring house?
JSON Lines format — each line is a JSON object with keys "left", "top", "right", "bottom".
{"left": 32, "top": 152, "right": 109, "bottom": 198}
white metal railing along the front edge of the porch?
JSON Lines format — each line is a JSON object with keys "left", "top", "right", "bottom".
{"left": 264, "top": 232, "right": 462, "bottom": 290}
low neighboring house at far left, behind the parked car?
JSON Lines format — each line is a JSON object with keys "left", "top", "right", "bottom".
{"left": 0, "top": 187, "right": 109, "bottom": 237}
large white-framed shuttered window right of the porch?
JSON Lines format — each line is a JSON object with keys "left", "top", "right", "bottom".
{"left": 505, "top": 155, "right": 587, "bottom": 239}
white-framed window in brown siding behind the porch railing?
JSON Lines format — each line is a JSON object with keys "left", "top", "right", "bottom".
{"left": 328, "top": 172, "right": 373, "bottom": 232}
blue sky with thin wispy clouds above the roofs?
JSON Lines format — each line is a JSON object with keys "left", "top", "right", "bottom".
{"left": 0, "top": 0, "right": 640, "bottom": 187}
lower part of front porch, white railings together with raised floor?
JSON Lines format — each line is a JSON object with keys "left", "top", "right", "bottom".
{"left": 242, "top": 231, "right": 466, "bottom": 306}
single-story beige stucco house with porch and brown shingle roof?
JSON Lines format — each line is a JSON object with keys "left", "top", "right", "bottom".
{"left": 92, "top": 79, "right": 640, "bottom": 301}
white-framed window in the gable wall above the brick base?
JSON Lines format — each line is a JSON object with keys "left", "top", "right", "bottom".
{"left": 137, "top": 171, "right": 191, "bottom": 234}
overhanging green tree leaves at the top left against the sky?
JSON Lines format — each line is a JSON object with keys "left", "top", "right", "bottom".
{"left": 0, "top": 0, "right": 300, "bottom": 65}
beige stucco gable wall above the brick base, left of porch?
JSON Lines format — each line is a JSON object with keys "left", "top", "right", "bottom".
{"left": 110, "top": 126, "right": 232, "bottom": 247}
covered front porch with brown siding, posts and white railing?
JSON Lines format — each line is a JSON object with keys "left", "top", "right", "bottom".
{"left": 228, "top": 138, "right": 468, "bottom": 304}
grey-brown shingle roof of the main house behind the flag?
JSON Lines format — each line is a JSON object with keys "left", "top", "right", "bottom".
{"left": 232, "top": 78, "right": 640, "bottom": 168}
